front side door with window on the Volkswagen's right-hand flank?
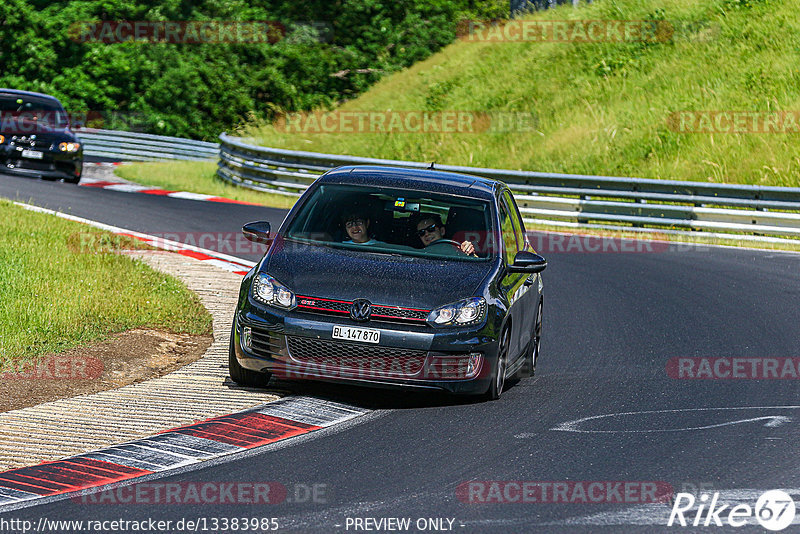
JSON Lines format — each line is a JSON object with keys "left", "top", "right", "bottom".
{"left": 497, "top": 193, "right": 528, "bottom": 366}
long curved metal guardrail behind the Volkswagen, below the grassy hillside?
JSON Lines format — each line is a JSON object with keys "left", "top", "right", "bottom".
{"left": 217, "top": 133, "right": 800, "bottom": 243}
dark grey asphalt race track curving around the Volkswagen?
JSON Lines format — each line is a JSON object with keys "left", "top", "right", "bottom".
{"left": 0, "top": 176, "right": 800, "bottom": 533}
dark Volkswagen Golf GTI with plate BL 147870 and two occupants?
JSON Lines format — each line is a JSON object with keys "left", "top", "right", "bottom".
{"left": 229, "top": 166, "right": 547, "bottom": 399}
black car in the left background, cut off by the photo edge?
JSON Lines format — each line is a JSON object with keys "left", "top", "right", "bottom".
{"left": 0, "top": 89, "right": 83, "bottom": 183}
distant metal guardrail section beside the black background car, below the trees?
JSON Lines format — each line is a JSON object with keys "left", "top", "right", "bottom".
{"left": 75, "top": 128, "right": 219, "bottom": 161}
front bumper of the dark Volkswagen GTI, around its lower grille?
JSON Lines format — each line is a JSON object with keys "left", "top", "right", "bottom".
{"left": 233, "top": 309, "right": 498, "bottom": 394}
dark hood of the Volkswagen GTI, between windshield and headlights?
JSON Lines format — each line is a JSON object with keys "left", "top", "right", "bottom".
{"left": 260, "top": 238, "right": 495, "bottom": 309}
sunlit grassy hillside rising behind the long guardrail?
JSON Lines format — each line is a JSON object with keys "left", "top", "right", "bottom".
{"left": 242, "top": 0, "right": 800, "bottom": 186}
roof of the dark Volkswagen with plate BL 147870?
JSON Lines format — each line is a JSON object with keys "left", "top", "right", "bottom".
{"left": 317, "top": 165, "right": 501, "bottom": 199}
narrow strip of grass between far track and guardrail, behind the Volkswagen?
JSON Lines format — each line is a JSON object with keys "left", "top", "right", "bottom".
{"left": 115, "top": 161, "right": 297, "bottom": 208}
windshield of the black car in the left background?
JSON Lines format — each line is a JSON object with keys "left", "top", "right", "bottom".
{"left": 0, "top": 94, "right": 68, "bottom": 134}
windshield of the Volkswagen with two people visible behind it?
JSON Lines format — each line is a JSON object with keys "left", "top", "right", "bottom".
{"left": 284, "top": 184, "right": 495, "bottom": 261}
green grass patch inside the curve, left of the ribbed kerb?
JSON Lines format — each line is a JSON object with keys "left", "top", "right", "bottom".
{"left": 0, "top": 200, "right": 211, "bottom": 369}
